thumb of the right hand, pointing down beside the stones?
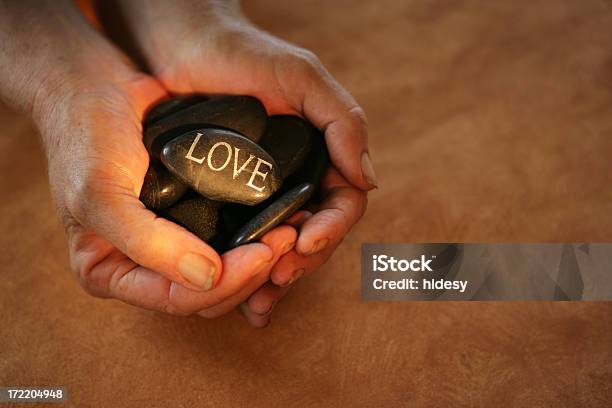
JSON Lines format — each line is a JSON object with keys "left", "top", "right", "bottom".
{"left": 283, "top": 53, "right": 378, "bottom": 190}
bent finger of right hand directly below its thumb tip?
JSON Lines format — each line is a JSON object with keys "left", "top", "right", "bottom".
{"left": 296, "top": 168, "right": 367, "bottom": 256}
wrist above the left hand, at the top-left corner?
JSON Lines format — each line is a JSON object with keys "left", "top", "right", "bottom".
{"left": 0, "top": 0, "right": 134, "bottom": 125}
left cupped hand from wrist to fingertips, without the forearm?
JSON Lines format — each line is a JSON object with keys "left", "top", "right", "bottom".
{"left": 43, "top": 73, "right": 296, "bottom": 317}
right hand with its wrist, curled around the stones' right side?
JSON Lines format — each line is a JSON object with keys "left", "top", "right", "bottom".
{"left": 114, "top": 0, "right": 376, "bottom": 326}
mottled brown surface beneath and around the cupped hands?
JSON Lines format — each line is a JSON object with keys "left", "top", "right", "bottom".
{"left": 0, "top": 0, "right": 612, "bottom": 407}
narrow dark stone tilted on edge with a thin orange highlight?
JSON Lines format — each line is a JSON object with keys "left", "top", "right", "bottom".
{"left": 227, "top": 183, "right": 315, "bottom": 249}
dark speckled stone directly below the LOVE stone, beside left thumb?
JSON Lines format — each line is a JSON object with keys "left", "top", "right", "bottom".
{"left": 162, "top": 197, "right": 219, "bottom": 241}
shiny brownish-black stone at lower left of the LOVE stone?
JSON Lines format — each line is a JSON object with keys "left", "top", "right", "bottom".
{"left": 140, "top": 160, "right": 187, "bottom": 210}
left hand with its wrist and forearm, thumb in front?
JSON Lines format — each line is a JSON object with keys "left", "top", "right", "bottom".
{"left": 0, "top": 1, "right": 296, "bottom": 317}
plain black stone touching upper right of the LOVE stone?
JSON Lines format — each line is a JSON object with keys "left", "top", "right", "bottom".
{"left": 259, "top": 115, "right": 312, "bottom": 178}
